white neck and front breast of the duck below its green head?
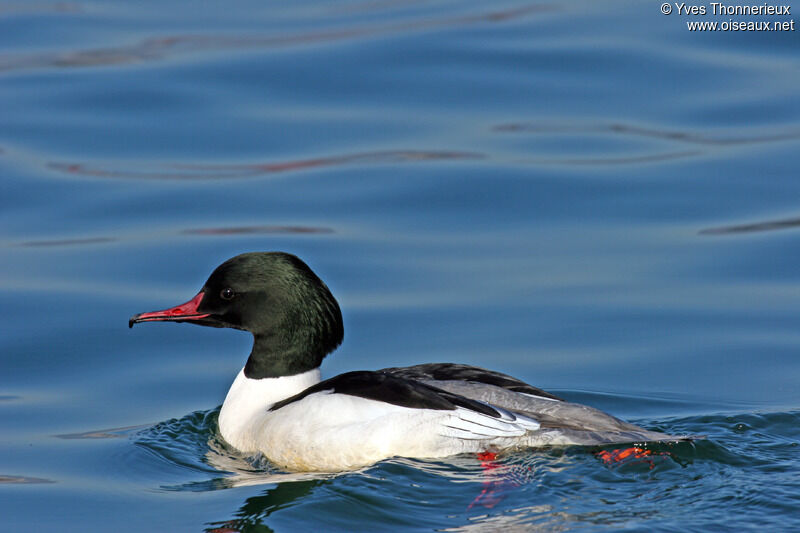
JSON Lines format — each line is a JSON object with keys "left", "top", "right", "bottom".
{"left": 219, "top": 368, "right": 321, "bottom": 452}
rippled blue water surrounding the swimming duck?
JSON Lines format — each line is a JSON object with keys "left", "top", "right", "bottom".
{"left": 0, "top": 0, "right": 800, "bottom": 533}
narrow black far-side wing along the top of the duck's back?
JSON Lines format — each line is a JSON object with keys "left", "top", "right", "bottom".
{"left": 380, "top": 363, "right": 563, "bottom": 401}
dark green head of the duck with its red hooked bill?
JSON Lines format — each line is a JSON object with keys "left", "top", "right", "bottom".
{"left": 129, "top": 252, "right": 344, "bottom": 379}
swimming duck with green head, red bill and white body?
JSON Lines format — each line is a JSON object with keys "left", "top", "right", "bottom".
{"left": 128, "top": 252, "right": 687, "bottom": 472}
